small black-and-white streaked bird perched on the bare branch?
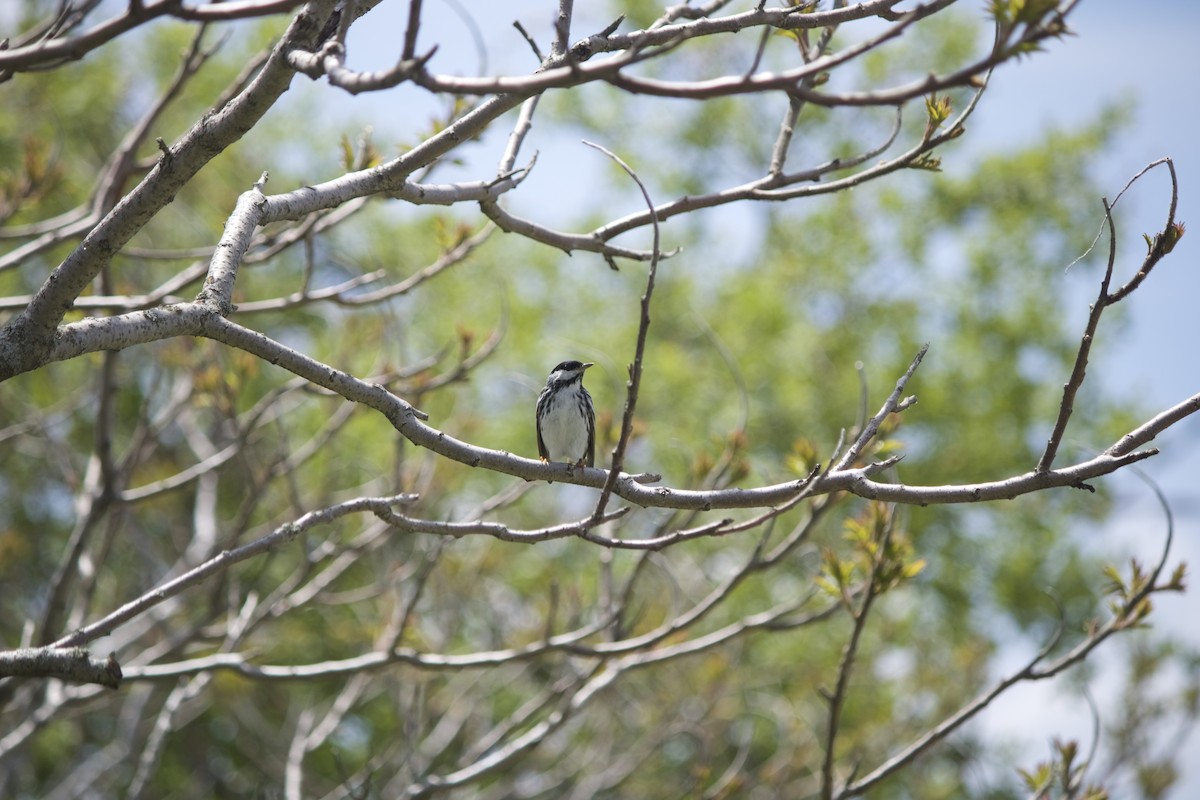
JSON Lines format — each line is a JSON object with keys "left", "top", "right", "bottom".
{"left": 538, "top": 361, "right": 596, "bottom": 467}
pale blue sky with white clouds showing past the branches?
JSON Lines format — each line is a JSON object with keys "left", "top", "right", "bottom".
{"left": 331, "top": 0, "right": 1200, "bottom": 799}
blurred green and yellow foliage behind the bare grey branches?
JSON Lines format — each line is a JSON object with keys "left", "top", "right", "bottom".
{"left": 0, "top": 4, "right": 1196, "bottom": 800}
